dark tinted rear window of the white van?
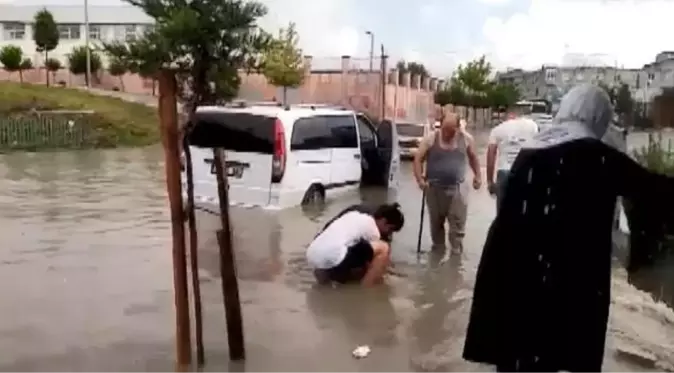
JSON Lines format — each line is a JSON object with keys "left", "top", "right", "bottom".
{"left": 188, "top": 112, "right": 276, "bottom": 154}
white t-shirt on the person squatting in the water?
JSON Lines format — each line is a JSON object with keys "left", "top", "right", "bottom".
{"left": 307, "top": 211, "right": 381, "bottom": 269}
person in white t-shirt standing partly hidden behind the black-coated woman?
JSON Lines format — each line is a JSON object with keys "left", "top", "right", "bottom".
{"left": 487, "top": 117, "right": 538, "bottom": 208}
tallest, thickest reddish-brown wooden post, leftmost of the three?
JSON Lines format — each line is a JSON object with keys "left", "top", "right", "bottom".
{"left": 159, "top": 70, "right": 192, "bottom": 365}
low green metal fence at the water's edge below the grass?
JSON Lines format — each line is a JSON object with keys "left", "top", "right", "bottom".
{"left": 0, "top": 111, "right": 93, "bottom": 151}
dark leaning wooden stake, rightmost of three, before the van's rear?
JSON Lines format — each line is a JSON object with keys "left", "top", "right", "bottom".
{"left": 213, "top": 149, "right": 246, "bottom": 360}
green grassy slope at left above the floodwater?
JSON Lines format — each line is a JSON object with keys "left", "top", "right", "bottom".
{"left": 0, "top": 82, "right": 159, "bottom": 147}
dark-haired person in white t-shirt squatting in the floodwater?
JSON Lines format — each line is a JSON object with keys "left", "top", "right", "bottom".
{"left": 307, "top": 203, "right": 405, "bottom": 286}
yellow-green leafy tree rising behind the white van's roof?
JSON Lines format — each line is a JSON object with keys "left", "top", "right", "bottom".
{"left": 262, "top": 23, "right": 305, "bottom": 105}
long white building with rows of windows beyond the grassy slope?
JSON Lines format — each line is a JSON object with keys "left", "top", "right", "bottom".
{"left": 0, "top": 4, "right": 153, "bottom": 66}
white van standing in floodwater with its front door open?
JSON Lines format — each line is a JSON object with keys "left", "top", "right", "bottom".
{"left": 183, "top": 105, "right": 400, "bottom": 208}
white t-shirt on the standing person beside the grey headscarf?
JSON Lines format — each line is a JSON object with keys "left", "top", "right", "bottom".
{"left": 489, "top": 118, "right": 538, "bottom": 171}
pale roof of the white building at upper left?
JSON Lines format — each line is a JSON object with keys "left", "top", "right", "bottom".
{"left": 0, "top": 4, "right": 154, "bottom": 24}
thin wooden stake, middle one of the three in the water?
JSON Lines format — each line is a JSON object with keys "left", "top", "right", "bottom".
{"left": 183, "top": 135, "right": 206, "bottom": 365}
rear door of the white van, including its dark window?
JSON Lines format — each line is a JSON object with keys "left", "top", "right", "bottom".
{"left": 188, "top": 110, "right": 276, "bottom": 206}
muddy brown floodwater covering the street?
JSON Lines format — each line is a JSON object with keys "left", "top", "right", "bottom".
{"left": 0, "top": 129, "right": 674, "bottom": 373}
